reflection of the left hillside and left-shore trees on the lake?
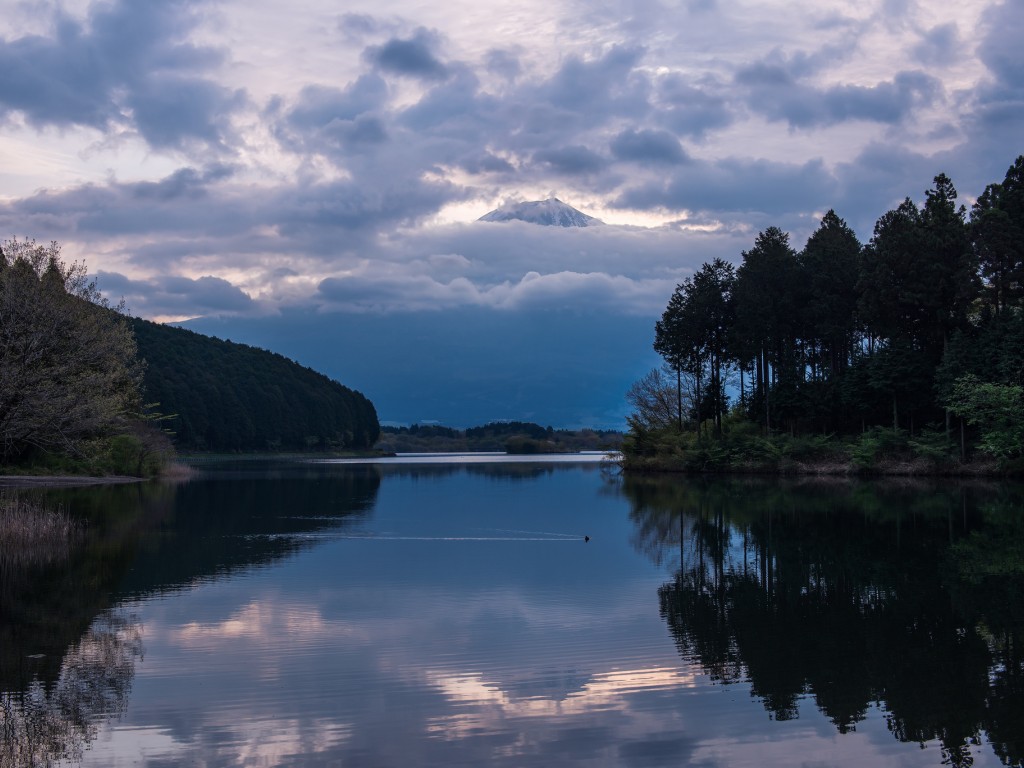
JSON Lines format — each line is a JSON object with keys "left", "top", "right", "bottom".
{"left": 0, "top": 465, "right": 380, "bottom": 768}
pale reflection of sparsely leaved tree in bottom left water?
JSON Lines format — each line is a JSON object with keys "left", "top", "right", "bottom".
{"left": 0, "top": 611, "right": 142, "bottom": 768}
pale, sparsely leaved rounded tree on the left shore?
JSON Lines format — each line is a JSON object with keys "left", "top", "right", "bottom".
{"left": 0, "top": 240, "right": 141, "bottom": 464}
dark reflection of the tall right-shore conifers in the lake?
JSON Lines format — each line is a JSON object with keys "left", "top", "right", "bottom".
{"left": 624, "top": 478, "right": 1024, "bottom": 766}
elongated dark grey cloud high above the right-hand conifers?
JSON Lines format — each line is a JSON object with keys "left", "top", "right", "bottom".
{"left": 735, "top": 60, "right": 942, "bottom": 128}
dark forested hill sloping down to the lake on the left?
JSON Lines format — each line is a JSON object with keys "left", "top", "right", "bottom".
{"left": 133, "top": 319, "right": 380, "bottom": 451}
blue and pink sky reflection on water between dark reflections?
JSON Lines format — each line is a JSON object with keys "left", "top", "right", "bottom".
{"left": 29, "top": 467, "right": 995, "bottom": 768}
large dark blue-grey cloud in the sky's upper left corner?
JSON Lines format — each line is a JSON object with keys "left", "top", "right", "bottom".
{"left": 0, "top": 0, "right": 246, "bottom": 147}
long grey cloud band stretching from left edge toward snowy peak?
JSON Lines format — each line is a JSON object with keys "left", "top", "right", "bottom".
{"left": 0, "top": 166, "right": 460, "bottom": 266}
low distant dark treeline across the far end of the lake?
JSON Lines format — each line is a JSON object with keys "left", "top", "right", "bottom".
{"left": 377, "top": 421, "right": 623, "bottom": 454}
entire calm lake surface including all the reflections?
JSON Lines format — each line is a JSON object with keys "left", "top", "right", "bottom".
{"left": 0, "top": 457, "right": 1024, "bottom": 768}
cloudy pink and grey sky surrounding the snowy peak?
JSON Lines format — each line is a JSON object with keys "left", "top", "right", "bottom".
{"left": 0, "top": 0, "right": 1024, "bottom": 428}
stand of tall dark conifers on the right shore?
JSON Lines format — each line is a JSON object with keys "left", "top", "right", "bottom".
{"left": 630, "top": 157, "right": 1024, "bottom": 468}
